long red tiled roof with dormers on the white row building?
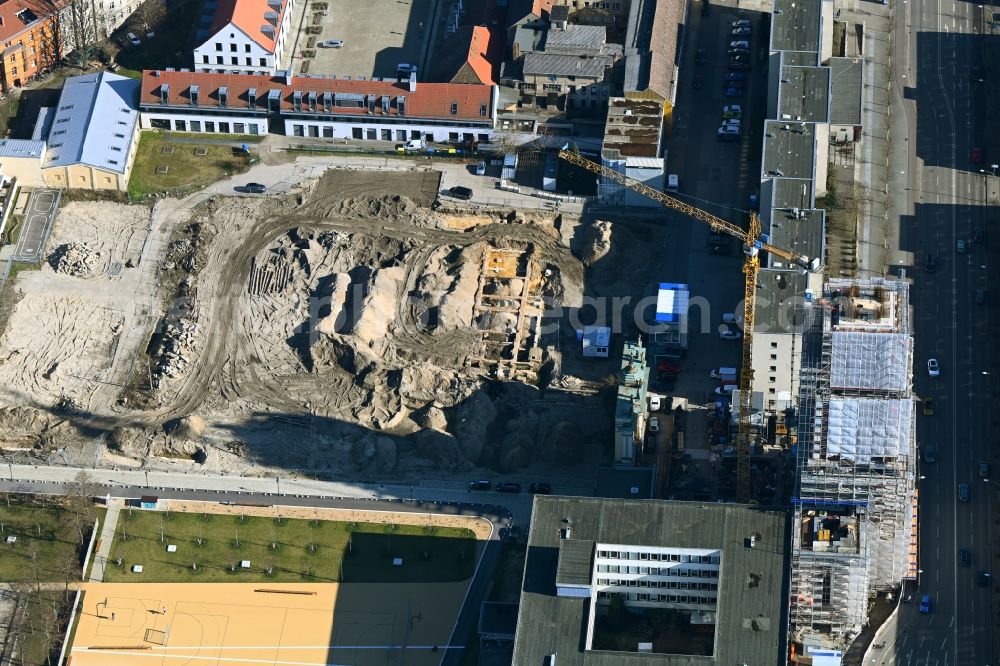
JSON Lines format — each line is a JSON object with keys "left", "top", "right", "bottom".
{"left": 139, "top": 70, "right": 493, "bottom": 121}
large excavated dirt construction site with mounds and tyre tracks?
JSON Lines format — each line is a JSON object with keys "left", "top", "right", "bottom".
{"left": 0, "top": 170, "right": 672, "bottom": 485}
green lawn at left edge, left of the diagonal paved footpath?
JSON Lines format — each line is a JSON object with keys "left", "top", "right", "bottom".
{"left": 0, "top": 499, "right": 103, "bottom": 583}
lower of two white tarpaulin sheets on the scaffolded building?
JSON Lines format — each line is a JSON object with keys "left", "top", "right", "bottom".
{"left": 826, "top": 397, "right": 913, "bottom": 464}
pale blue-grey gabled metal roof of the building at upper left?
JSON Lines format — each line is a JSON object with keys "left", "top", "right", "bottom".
{"left": 42, "top": 72, "right": 141, "bottom": 173}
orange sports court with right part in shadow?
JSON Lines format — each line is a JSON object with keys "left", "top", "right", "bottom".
{"left": 69, "top": 581, "right": 470, "bottom": 666}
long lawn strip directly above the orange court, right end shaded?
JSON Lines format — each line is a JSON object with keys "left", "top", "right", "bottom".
{"left": 104, "top": 509, "right": 478, "bottom": 583}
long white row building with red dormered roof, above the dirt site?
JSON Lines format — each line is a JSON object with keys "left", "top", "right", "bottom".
{"left": 139, "top": 71, "right": 496, "bottom": 144}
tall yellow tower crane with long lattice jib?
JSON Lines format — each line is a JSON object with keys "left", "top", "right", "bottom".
{"left": 559, "top": 144, "right": 820, "bottom": 502}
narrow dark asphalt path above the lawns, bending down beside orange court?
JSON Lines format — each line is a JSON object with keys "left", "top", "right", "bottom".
{"left": 0, "top": 474, "right": 511, "bottom": 666}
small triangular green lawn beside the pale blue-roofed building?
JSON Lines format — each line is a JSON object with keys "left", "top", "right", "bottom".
{"left": 128, "top": 130, "right": 249, "bottom": 197}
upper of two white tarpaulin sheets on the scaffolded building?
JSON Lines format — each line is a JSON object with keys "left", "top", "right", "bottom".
{"left": 830, "top": 331, "right": 913, "bottom": 392}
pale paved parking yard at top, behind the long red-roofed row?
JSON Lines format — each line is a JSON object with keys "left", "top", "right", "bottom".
{"left": 290, "top": 0, "right": 437, "bottom": 78}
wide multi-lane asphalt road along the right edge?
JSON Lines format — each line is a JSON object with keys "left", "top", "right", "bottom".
{"left": 872, "top": 0, "right": 997, "bottom": 666}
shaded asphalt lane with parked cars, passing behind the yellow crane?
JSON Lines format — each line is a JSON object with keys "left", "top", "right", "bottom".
{"left": 651, "top": 0, "right": 769, "bottom": 499}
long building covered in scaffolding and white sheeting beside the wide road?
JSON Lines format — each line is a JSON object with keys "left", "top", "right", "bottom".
{"left": 789, "top": 278, "right": 916, "bottom": 663}
